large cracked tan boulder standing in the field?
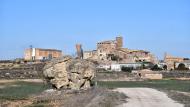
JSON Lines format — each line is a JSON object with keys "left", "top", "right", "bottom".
{"left": 43, "top": 56, "right": 96, "bottom": 89}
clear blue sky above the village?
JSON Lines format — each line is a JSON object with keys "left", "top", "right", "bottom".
{"left": 0, "top": 0, "right": 190, "bottom": 59}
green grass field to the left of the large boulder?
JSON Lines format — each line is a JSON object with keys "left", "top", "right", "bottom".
{"left": 0, "top": 81, "right": 48, "bottom": 100}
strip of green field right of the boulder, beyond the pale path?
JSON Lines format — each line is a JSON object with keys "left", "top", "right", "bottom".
{"left": 97, "top": 80, "right": 190, "bottom": 92}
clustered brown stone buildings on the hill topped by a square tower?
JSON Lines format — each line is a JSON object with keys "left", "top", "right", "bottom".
{"left": 84, "top": 37, "right": 155, "bottom": 63}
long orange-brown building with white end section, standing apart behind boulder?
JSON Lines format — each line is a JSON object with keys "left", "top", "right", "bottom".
{"left": 24, "top": 48, "right": 62, "bottom": 60}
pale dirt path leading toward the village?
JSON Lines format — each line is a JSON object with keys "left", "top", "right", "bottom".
{"left": 116, "top": 88, "right": 183, "bottom": 107}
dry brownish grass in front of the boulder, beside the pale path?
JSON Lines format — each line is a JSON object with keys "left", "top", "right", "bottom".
{"left": 30, "top": 88, "right": 126, "bottom": 107}
